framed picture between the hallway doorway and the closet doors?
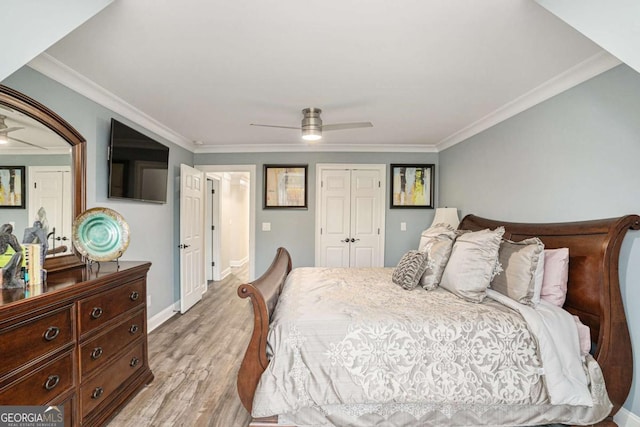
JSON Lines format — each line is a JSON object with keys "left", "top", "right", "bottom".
{"left": 264, "top": 165, "right": 307, "bottom": 209}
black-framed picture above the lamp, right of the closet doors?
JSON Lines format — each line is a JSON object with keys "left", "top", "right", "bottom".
{"left": 391, "top": 164, "right": 435, "bottom": 209}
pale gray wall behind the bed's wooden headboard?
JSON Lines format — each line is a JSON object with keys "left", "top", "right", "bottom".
{"left": 440, "top": 65, "right": 640, "bottom": 415}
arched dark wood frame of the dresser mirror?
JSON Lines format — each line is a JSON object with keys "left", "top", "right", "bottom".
{"left": 0, "top": 85, "right": 87, "bottom": 272}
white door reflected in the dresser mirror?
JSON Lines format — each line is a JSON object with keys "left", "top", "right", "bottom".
{"left": 28, "top": 166, "right": 73, "bottom": 255}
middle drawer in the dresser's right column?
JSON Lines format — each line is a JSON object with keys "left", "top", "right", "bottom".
{"left": 80, "top": 310, "right": 146, "bottom": 381}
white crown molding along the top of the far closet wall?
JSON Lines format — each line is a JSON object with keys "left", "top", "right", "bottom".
{"left": 193, "top": 142, "right": 437, "bottom": 154}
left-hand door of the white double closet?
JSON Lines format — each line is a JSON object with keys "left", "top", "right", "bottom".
{"left": 320, "top": 170, "right": 351, "bottom": 267}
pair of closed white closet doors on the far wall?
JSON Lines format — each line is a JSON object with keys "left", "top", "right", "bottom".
{"left": 316, "top": 165, "right": 384, "bottom": 267}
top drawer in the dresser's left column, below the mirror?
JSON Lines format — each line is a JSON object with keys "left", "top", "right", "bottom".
{"left": 0, "top": 305, "right": 75, "bottom": 378}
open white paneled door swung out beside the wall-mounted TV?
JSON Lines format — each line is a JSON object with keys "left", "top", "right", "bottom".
{"left": 178, "top": 165, "right": 207, "bottom": 313}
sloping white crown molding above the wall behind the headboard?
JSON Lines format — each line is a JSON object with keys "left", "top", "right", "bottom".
{"left": 435, "top": 50, "right": 622, "bottom": 152}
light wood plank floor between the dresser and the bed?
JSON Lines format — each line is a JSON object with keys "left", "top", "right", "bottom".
{"left": 108, "top": 264, "right": 253, "bottom": 427}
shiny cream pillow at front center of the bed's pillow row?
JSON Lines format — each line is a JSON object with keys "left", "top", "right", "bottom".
{"left": 440, "top": 227, "right": 504, "bottom": 302}
